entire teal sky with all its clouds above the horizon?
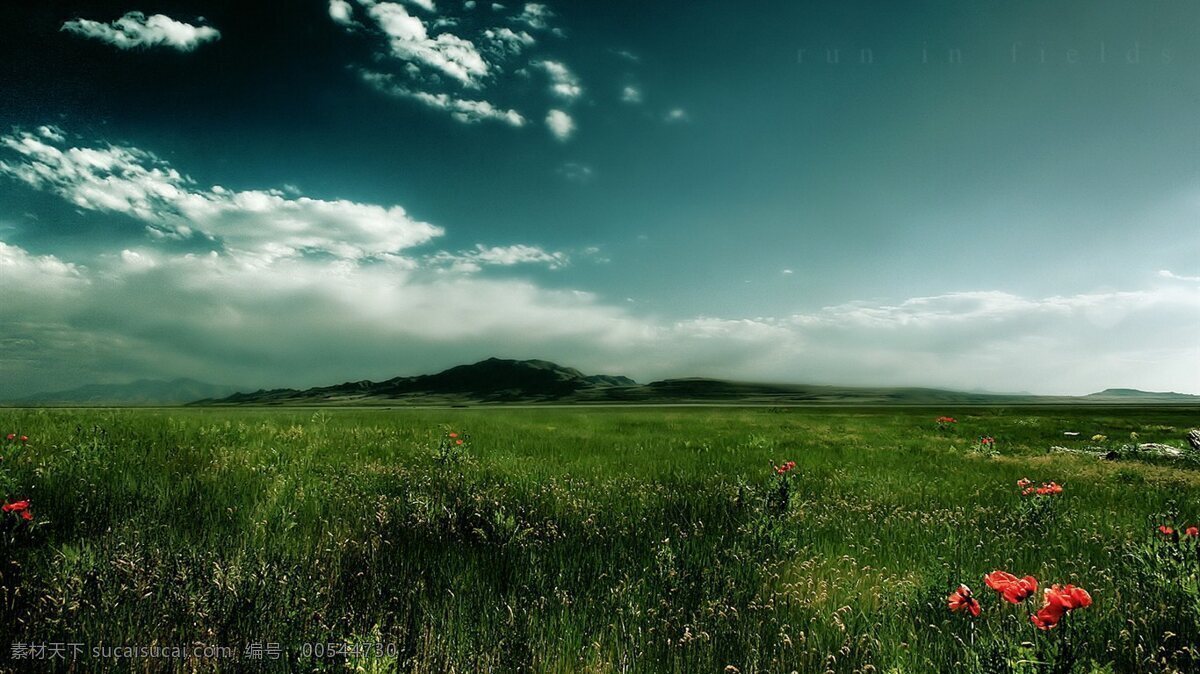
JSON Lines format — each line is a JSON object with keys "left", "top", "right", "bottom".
{"left": 0, "top": 0, "right": 1200, "bottom": 398}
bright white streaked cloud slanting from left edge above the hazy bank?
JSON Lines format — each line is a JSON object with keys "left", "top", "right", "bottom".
{"left": 0, "top": 132, "right": 442, "bottom": 259}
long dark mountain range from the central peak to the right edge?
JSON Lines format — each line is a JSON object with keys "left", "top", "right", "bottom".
{"left": 197, "top": 359, "right": 1200, "bottom": 405}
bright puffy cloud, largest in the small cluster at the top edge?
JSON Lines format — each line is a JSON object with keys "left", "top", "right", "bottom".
{"left": 367, "top": 2, "right": 488, "bottom": 88}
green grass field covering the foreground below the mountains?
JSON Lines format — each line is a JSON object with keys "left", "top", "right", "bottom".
{"left": 0, "top": 408, "right": 1200, "bottom": 674}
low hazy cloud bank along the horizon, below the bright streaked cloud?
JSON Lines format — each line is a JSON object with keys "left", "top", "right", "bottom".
{"left": 0, "top": 230, "right": 1200, "bottom": 396}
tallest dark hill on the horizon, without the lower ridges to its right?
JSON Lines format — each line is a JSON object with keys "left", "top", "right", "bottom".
{"left": 200, "top": 359, "right": 637, "bottom": 404}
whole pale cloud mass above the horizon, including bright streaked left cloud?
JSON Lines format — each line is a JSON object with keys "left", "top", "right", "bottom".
{"left": 0, "top": 126, "right": 1200, "bottom": 398}
